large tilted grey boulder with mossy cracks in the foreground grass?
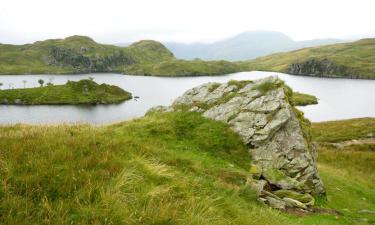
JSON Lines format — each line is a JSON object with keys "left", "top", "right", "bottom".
{"left": 153, "top": 77, "right": 325, "bottom": 209}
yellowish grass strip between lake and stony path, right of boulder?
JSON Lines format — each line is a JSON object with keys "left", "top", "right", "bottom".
{"left": 312, "top": 118, "right": 375, "bottom": 142}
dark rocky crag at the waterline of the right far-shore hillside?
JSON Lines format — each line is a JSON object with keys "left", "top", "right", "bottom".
{"left": 286, "top": 58, "right": 356, "bottom": 78}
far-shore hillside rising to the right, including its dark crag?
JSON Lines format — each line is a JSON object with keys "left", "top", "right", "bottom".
{"left": 244, "top": 39, "right": 375, "bottom": 78}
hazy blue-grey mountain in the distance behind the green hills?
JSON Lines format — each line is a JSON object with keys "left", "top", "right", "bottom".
{"left": 163, "top": 31, "right": 344, "bottom": 61}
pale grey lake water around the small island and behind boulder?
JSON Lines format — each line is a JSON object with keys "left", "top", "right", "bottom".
{"left": 0, "top": 72, "right": 375, "bottom": 124}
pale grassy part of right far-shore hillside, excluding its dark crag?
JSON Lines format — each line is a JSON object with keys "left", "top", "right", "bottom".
{"left": 240, "top": 39, "right": 375, "bottom": 78}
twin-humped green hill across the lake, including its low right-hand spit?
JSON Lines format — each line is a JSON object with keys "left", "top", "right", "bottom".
{"left": 0, "top": 36, "right": 240, "bottom": 76}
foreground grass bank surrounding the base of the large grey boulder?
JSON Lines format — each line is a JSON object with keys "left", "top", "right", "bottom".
{"left": 0, "top": 112, "right": 375, "bottom": 225}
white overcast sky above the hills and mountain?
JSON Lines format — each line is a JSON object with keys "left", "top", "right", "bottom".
{"left": 0, "top": 0, "right": 375, "bottom": 44}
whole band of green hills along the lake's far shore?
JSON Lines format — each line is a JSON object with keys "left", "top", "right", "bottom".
{"left": 0, "top": 36, "right": 375, "bottom": 79}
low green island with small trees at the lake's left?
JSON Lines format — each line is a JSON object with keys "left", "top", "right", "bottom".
{"left": 0, "top": 79, "right": 132, "bottom": 105}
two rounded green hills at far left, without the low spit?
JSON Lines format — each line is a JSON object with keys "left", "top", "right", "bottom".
{"left": 0, "top": 36, "right": 174, "bottom": 74}
